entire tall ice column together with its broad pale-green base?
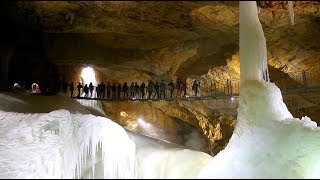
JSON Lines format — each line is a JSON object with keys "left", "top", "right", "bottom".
{"left": 198, "top": 1, "right": 320, "bottom": 178}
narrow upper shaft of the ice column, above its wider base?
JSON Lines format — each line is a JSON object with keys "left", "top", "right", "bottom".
{"left": 239, "top": 2, "right": 269, "bottom": 84}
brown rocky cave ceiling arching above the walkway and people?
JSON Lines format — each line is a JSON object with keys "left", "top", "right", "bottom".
{"left": 1, "top": 1, "right": 320, "bottom": 81}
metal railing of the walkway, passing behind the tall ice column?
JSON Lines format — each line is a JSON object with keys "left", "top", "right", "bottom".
{"left": 64, "top": 71, "right": 320, "bottom": 101}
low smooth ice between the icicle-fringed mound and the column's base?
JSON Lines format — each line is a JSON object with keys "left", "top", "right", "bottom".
{"left": 130, "top": 132, "right": 212, "bottom": 179}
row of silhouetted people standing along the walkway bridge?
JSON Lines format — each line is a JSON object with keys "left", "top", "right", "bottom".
{"left": 62, "top": 79, "right": 200, "bottom": 100}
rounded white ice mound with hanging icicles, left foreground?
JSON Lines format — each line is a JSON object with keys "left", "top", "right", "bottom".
{"left": 0, "top": 110, "right": 135, "bottom": 178}
